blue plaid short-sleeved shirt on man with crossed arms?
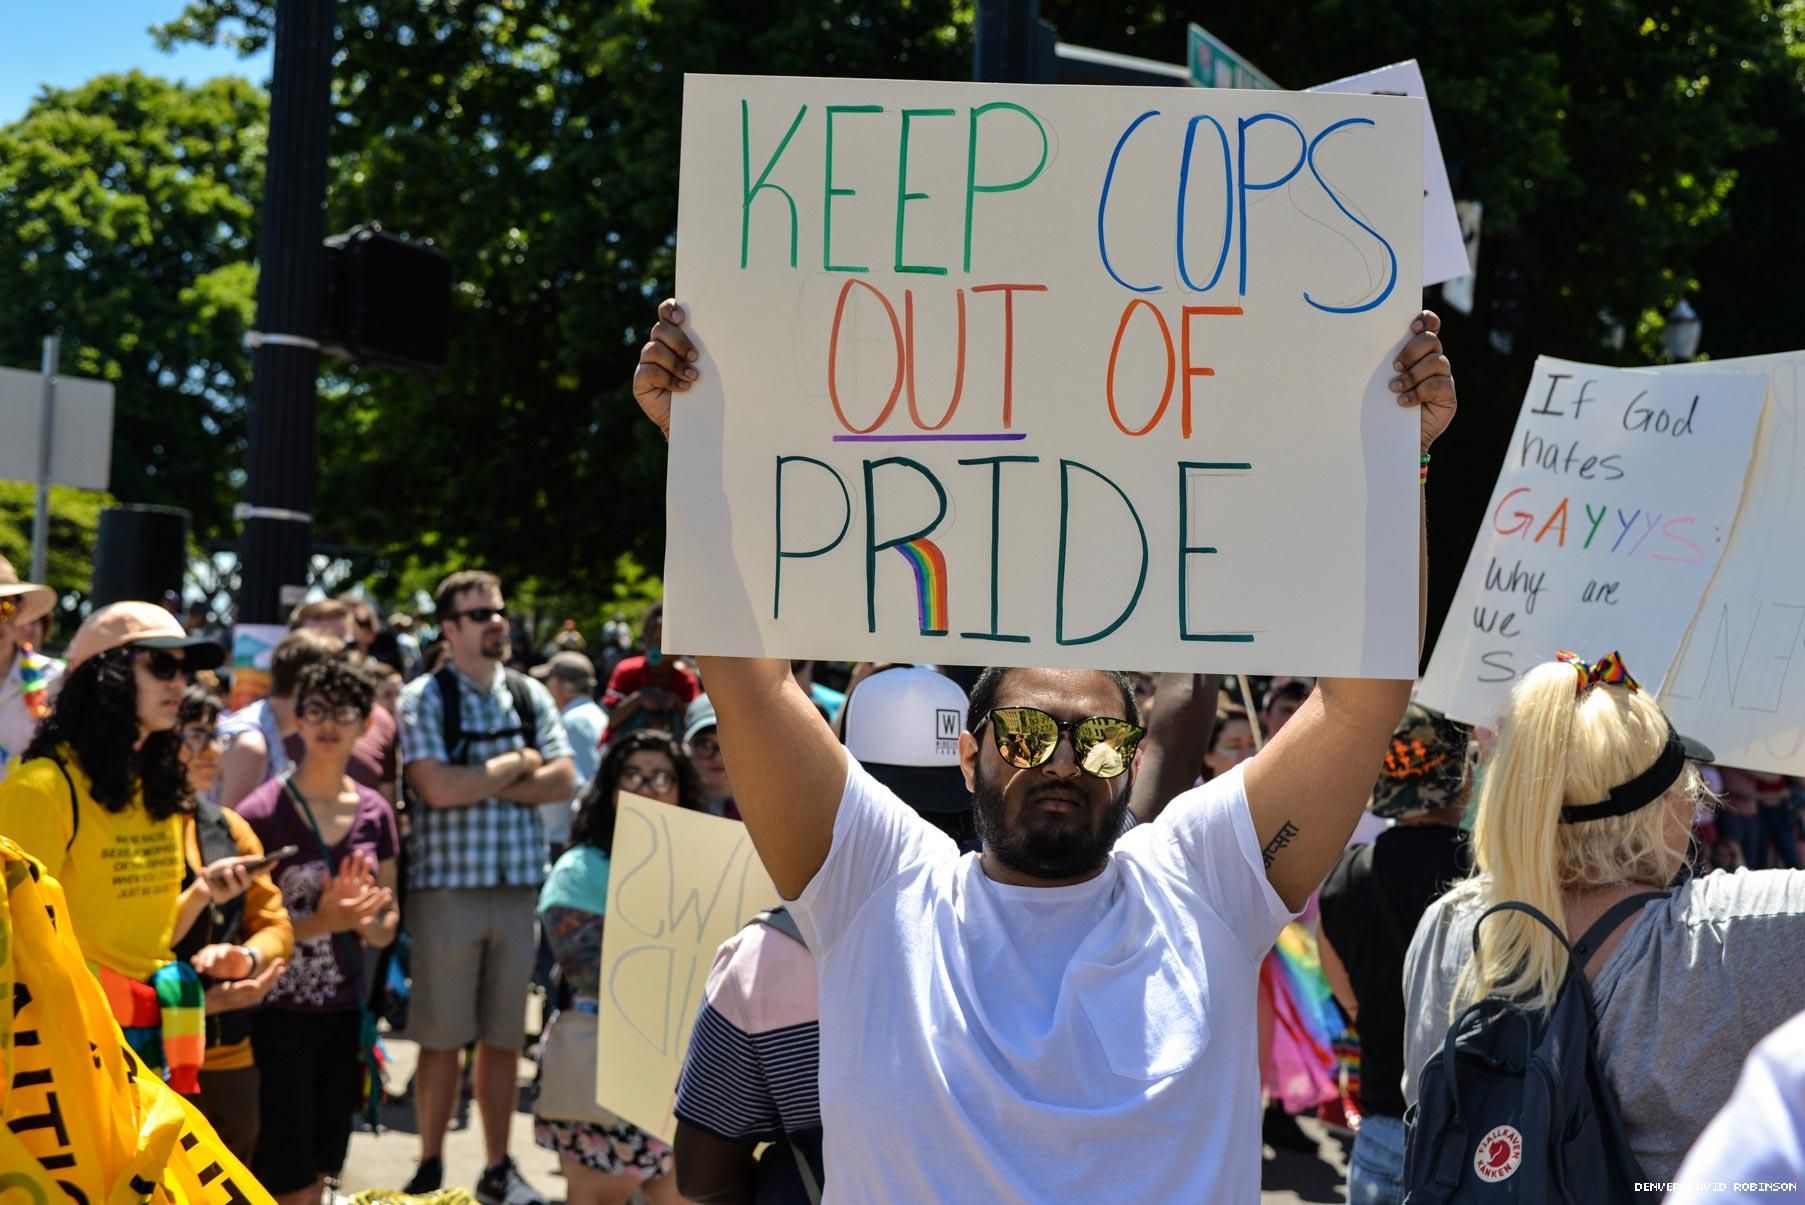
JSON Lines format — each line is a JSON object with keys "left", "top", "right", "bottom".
{"left": 401, "top": 667, "right": 570, "bottom": 891}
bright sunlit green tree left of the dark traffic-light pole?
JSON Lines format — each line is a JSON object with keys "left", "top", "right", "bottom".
{"left": 0, "top": 72, "right": 267, "bottom": 541}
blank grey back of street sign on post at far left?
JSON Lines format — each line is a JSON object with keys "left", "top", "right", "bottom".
{"left": 0, "top": 368, "right": 114, "bottom": 489}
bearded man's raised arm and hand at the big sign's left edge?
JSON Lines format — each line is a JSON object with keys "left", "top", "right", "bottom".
{"left": 634, "top": 301, "right": 847, "bottom": 900}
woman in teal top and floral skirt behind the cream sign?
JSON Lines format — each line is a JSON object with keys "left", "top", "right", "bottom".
{"left": 532, "top": 731, "right": 702, "bottom": 1205}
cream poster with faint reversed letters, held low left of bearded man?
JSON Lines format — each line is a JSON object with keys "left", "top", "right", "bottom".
{"left": 596, "top": 792, "right": 782, "bottom": 1142}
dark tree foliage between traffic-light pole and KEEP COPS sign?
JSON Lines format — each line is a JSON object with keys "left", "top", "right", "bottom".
{"left": 164, "top": 0, "right": 969, "bottom": 597}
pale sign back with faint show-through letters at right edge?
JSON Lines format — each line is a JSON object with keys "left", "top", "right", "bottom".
{"left": 1661, "top": 352, "right": 1805, "bottom": 774}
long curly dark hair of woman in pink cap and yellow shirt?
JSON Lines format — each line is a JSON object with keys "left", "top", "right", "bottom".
{"left": 25, "top": 646, "right": 191, "bottom": 821}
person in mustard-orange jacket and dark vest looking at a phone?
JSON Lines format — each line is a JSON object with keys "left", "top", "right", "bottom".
{"left": 175, "top": 685, "right": 294, "bottom": 1165}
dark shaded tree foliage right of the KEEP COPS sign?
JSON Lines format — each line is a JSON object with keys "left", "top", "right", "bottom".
{"left": 1041, "top": 0, "right": 1805, "bottom": 660}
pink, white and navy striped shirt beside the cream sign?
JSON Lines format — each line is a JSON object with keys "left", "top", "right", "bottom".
{"left": 677, "top": 924, "right": 821, "bottom": 1147}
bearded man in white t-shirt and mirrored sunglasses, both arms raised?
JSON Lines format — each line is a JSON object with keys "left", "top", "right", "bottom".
{"left": 634, "top": 301, "right": 1455, "bottom": 1201}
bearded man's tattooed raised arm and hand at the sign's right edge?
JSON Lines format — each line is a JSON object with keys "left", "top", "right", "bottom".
{"left": 1244, "top": 310, "right": 1455, "bottom": 909}
